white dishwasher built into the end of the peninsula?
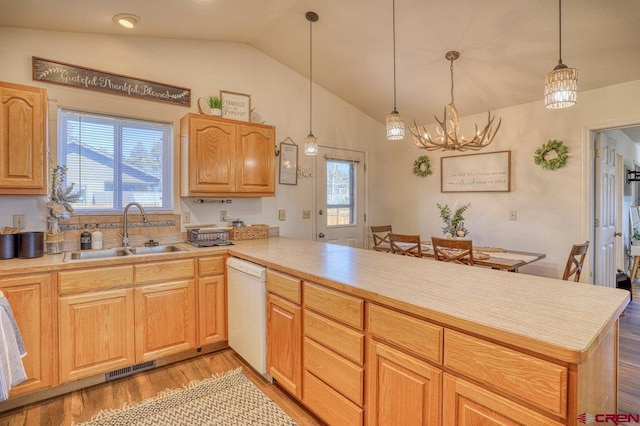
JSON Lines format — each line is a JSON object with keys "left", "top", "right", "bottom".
{"left": 227, "top": 257, "right": 268, "bottom": 377}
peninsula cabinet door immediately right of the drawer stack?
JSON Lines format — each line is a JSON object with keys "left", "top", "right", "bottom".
{"left": 367, "top": 340, "right": 442, "bottom": 426}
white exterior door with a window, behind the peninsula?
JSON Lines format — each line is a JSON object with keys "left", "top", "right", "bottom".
{"left": 316, "top": 147, "right": 365, "bottom": 248}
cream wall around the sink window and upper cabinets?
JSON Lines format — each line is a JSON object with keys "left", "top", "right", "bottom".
{"left": 0, "top": 27, "right": 386, "bottom": 239}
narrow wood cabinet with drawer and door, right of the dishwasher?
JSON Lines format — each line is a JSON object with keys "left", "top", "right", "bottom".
{"left": 267, "top": 270, "right": 302, "bottom": 398}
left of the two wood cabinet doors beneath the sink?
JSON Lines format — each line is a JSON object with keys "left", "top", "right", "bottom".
{"left": 58, "top": 289, "right": 134, "bottom": 382}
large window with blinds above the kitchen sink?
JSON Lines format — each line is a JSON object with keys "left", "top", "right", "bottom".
{"left": 58, "top": 110, "right": 173, "bottom": 213}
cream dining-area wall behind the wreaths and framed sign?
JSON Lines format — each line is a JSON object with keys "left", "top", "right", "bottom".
{"left": 378, "top": 81, "right": 640, "bottom": 278}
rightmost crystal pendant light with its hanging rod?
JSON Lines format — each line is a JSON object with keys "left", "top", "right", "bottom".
{"left": 544, "top": 0, "right": 578, "bottom": 109}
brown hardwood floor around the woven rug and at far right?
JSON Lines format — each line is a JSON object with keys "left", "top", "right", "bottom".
{"left": 0, "top": 284, "right": 640, "bottom": 426}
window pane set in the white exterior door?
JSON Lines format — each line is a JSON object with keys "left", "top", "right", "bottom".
{"left": 327, "top": 159, "right": 356, "bottom": 226}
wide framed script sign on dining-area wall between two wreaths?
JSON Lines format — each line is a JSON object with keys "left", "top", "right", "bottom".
{"left": 440, "top": 151, "right": 511, "bottom": 192}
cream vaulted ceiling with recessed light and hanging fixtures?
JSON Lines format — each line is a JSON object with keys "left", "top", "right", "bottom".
{"left": 0, "top": 0, "right": 640, "bottom": 131}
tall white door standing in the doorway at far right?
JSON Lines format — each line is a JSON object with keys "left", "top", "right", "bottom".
{"left": 593, "top": 132, "right": 618, "bottom": 288}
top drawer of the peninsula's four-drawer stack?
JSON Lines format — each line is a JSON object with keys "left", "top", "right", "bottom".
{"left": 304, "top": 281, "right": 364, "bottom": 330}
